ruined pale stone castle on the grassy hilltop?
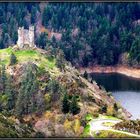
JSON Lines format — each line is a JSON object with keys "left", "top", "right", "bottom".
{"left": 17, "top": 26, "right": 35, "bottom": 48}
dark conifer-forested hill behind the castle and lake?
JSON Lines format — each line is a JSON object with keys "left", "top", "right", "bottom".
{"left": 0, "top": 3, "right": 140, "bottom": 66}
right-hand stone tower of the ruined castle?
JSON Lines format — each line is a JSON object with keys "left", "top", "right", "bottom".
{"left": 29, "top": 26, "right": 34, "bottom": 47}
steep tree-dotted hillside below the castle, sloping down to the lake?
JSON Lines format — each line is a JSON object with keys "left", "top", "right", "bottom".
{"left": 0, "top": 46, "right": 130, "bottom": 137}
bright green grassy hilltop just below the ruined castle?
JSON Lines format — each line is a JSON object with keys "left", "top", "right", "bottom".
{"left": 0, "top": 48, "right": 56, "bottom": 69}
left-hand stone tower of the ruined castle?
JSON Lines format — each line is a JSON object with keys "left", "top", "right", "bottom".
{"left": 17, "top": 27, "right": 24, "bottom": 48}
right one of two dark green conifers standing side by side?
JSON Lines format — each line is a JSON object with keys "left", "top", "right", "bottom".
{"left": 70, "top": 95, "right": 80, "bottom": 115}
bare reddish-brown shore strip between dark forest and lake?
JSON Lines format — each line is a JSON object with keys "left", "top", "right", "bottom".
{"left": 79, "top": 65, "right": 140, "bottom": 79}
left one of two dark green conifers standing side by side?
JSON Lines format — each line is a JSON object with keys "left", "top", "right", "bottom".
{"left": 62, "top": 93, "right": 70, "bottom": 113}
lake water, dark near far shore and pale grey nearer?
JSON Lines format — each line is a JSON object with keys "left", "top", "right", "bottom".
{"left": 91, "top": 73, "right": 140, "bottom": 119}
